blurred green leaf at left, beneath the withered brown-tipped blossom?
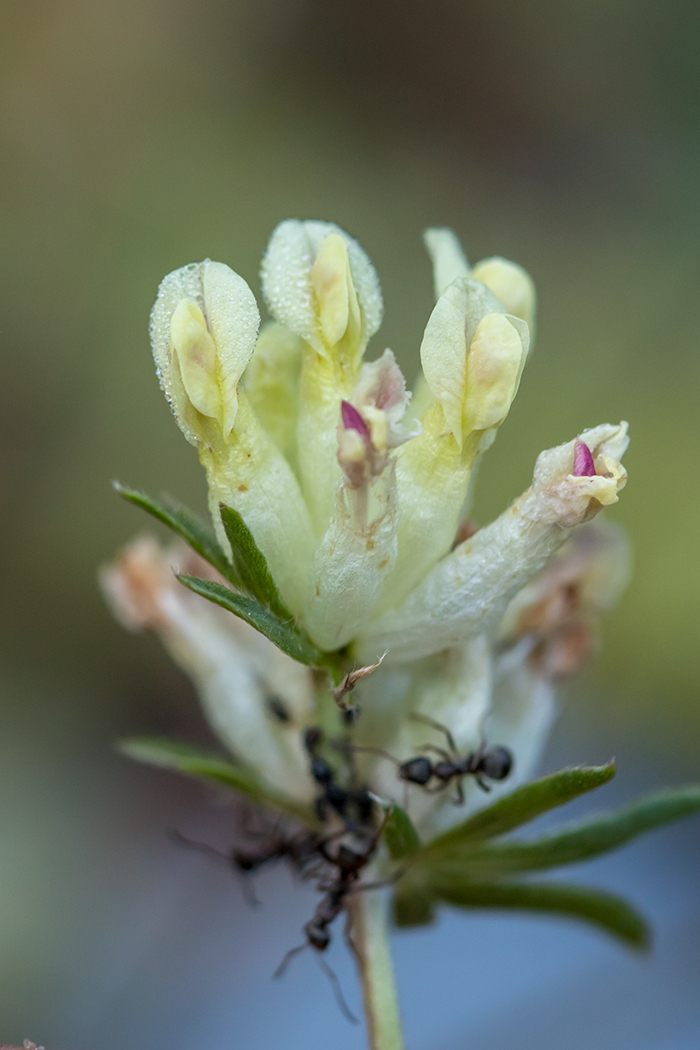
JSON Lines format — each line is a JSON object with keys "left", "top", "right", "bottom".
{"left": 118, "top": 737, "right": 314, "bottom": 823}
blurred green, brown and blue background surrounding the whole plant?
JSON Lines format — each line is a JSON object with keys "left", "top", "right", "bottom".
{"left": 0, "top": 0, "right": 700, "bottom": 1050}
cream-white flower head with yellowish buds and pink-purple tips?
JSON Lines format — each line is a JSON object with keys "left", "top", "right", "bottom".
{"left": 102, "top": 221, "right": 628, "bottom": 835}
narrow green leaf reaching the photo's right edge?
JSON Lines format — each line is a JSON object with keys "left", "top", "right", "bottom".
{"left": 432, "top": 784, "right": 700, "bottom": 880}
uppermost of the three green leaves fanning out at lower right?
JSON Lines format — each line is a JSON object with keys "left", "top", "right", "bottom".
{"left": 416, "top": 762, "right": 615, "bottom": 862}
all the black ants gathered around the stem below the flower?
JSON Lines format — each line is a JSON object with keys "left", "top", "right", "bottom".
{"left": 176, "top": 697, "right": 513, "bottom": 1023}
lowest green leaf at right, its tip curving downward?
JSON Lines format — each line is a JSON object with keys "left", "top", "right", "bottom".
{"left": 429, "top": 879, "right": 650, "bottom": 949}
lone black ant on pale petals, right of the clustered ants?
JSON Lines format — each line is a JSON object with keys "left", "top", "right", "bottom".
{"left": 354, "top": 714, "right": 513, "bottom": 805}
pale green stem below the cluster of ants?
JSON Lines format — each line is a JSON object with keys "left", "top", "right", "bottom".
{"left": 351, "top": 891, "right": 404, "bottom": 1050}
